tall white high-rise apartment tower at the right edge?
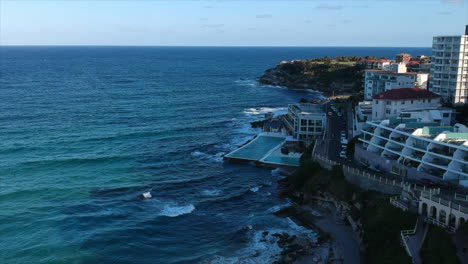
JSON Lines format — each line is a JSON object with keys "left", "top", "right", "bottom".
{"left": 430, "top": 26, "right": 468, "bottom": 104}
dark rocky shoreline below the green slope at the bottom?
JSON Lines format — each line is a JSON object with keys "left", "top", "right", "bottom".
{"left": 273, "top": 172, "right": 361, "bottom": 264}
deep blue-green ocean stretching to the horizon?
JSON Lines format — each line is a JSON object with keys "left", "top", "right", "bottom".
{"left": 0, "top": 47, "right": 430, "bottom": 264}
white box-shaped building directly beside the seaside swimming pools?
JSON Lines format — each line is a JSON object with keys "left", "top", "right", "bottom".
{"left": 283, "top": 103, "right": 327, "bottom": 142}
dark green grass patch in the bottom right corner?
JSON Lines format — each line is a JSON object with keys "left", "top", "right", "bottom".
{"left": 420, "top": 225, "right": 460, "bottom": 264}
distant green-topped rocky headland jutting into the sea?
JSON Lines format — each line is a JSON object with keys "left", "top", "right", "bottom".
{"left": 259, "top": 60, "right": 363, "bottom": 95}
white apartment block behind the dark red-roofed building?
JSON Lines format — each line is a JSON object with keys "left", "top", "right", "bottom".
{"left": 364, "top": 69, "right": 429, "bottom": 100}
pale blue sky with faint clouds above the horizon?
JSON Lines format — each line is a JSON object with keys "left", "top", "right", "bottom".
{"left": 0, "top": 0, "right": 468, "bottom": 47}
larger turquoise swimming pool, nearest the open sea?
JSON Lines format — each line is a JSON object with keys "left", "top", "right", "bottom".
{"left": 226, "top": 136, "right": 285, "bottom": 160}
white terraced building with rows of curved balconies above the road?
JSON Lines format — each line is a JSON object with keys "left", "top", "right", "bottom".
{"left": 355, "top": 118, "right": 468, "bottom": 186}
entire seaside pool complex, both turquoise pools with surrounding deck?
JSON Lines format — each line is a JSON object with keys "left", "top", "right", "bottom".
{"left": 224, "top": 133, "right": 300, "bottom": 168}
